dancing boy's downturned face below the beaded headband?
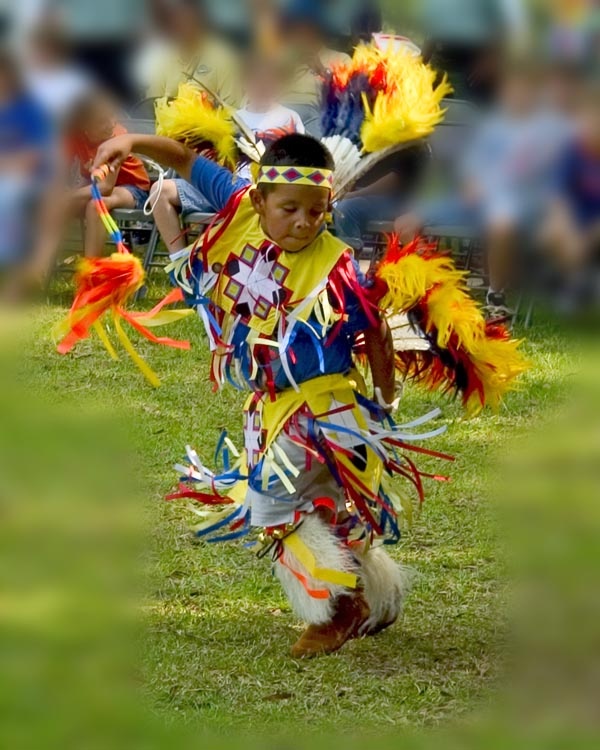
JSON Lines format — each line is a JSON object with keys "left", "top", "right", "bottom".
{"left": 251, "top": 185, "right": 330, "bottom": 253}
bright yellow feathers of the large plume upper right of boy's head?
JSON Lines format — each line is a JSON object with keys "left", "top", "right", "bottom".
{"left": 359, "top": 48, "right": 452, "bottom": 153}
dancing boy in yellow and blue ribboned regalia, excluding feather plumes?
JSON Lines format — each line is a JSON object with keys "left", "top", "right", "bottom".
{"left": 92, "top": 129, "right": 524, "bottom": 657}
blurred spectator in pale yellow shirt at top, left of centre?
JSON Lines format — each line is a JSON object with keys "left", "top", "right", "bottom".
{"left": 147, "top": 0, "right": 241, "bottom": 106}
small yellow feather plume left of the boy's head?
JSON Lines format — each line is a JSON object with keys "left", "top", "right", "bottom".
{"left": 156, "top": 83, "right": 237, "bottom": 167}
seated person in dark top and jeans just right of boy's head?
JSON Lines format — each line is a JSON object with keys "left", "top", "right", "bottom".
{"left": 333, "top": 144, "right": 428, "bottom": 253}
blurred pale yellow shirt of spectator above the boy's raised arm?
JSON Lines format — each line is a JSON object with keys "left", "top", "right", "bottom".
{"left": 148, "top": 38, "right": 241, "bottom": 107}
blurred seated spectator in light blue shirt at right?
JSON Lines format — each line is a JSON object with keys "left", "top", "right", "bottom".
{"left": 395, "top": 61, "right": 568, "bottom": 316}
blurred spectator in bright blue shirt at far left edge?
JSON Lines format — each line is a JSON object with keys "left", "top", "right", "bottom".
{"left": 0, "top": 48, "right": 53, "bottom": 297}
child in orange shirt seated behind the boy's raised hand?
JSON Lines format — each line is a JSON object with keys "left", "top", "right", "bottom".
{"left": 68, "top": 93, "right": 150, "bottom": 257}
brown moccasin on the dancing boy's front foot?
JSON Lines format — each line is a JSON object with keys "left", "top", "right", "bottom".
{"left": 291, "top": 592, "right": 370, "bottom": 659}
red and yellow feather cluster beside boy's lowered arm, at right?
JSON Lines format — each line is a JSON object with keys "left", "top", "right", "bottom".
{"left": 375, "top": 237, "right": 529, "bottom": 416}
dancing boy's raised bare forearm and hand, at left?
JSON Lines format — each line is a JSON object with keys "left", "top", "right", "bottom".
{"left": 93, "top": 133, "right": 197, "bottom": 180}
